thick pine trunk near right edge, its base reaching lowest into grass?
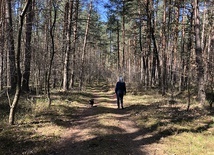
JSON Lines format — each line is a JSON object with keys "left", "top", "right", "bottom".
{"left": 193, "top": 0, "right": 205, "bottom": 106}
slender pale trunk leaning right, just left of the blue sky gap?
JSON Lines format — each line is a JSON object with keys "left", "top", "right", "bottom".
{"left": 79, "top": 0, "right": 92, "bottom": 90}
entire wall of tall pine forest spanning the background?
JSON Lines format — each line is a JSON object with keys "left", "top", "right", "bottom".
{"left": 0, "top": 0, "right": 214, "bottom": 108}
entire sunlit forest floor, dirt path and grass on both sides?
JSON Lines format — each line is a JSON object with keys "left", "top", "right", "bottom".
{"left": 0, "top": 87, "right": 214, "bottom": 155}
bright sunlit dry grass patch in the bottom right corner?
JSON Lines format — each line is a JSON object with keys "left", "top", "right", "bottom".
{"left": 160, "top": 132, "right": 214, "bottom": 155}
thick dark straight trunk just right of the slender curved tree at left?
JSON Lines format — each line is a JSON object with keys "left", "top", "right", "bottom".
{"left": 22, "top": 0, "right": 34, "bottom": 92}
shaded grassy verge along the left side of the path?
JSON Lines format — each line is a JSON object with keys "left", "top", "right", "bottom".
{"left": 0, "top": 92, "right": 92, "bottom": 155}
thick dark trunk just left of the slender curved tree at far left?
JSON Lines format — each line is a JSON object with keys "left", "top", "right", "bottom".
{"left": 6, "top": 0, "right": 17, "bottom": 91}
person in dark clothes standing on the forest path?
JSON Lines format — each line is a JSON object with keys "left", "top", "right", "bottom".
{"left": 115, "top": 76, "right": 126, "bottom": 109}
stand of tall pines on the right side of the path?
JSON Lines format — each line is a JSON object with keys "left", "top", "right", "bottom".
{"left": 107, "top": 0, "right": 214, "bottom": 105}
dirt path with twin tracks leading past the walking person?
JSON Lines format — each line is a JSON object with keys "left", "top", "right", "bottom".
{"left": 51, "top": 89, "right": 163, "bottom": 155}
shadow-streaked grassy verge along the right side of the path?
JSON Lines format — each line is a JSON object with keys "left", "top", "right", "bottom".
{"left": 126, "top": 91, "right": 214, "bottom": 155}
